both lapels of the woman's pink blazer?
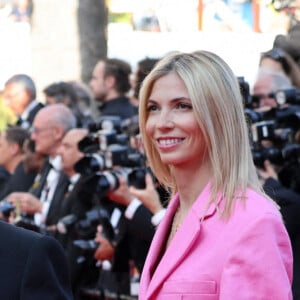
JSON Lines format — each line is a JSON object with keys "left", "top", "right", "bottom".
{"left": 143, "top": 183, "right": 219, "bottom": 299}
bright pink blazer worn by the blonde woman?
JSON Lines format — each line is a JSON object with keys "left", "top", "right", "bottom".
{"left": 139, "top": 184, "right": 293, "bottom": 300}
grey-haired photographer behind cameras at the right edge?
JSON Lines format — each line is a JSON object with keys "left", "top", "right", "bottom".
{"left": 248, "top": 69, "right": 300, "bottom": 299}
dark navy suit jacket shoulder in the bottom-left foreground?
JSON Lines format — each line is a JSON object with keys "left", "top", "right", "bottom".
{"left": 0, "top": 221, "right": 73, "bottom": 300}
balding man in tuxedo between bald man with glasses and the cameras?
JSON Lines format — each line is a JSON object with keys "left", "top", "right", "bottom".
{"left": 50, "top": 128, "right": 102, "bottom": 298}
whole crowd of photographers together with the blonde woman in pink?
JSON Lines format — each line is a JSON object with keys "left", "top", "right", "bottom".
{"left": 0, "top": 22, "right": 300, "bottom": 300}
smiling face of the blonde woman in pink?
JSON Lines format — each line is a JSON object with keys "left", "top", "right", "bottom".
{"left": 146, "top": 73, "right": 205, "bottom": 166}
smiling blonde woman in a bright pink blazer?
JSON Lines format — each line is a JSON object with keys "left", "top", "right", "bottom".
{"left": 139, "top": 51, "right": 292, "bottom": 300}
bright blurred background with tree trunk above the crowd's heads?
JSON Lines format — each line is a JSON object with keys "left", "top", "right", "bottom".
{"left": 0, "top": 0, "right": 300, "bottom": 96}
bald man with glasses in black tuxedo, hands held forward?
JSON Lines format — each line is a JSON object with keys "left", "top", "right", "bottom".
{"left": 8, "top": 104, "right": 76, "bottom": 230}
